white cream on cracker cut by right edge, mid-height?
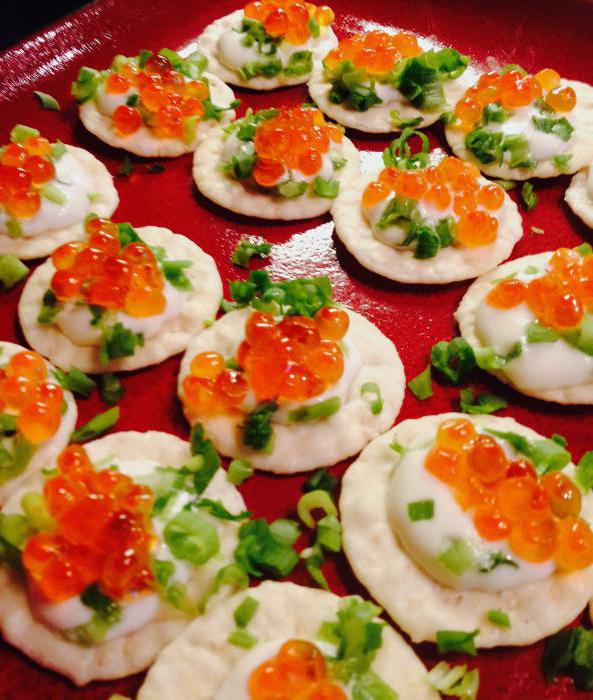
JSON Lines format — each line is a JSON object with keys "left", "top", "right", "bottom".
{"left": 475, "top": 254, "right": 593, "bottom": 391}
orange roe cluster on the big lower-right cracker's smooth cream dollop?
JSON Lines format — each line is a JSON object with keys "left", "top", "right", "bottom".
{"left": 424, "top": 418, "right": 593, "bottom": 570}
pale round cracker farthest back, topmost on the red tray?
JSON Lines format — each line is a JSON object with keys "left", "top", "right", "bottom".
{"left": 196, "top": 10, "right": 338, "bottom": 90}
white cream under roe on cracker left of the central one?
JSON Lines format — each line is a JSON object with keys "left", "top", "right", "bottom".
{"left": 54, "top": 280, "right": 185, "bottom": 346}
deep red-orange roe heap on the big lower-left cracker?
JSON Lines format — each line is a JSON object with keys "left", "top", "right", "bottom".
{"left": 23, "top": 445, "right": 154, "bottom": 603}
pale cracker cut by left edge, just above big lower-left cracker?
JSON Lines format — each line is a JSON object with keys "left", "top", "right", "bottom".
{"left": 0, "top": 341, "right": 78, "bottom": 506}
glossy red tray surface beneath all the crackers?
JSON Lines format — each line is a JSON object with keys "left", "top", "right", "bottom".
{"left": 0, "top": 0, "right": 593, "bottom": 700}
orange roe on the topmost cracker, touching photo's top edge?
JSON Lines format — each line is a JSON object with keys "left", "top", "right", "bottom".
{"left": 243, "top": 0, "right": 335, "bottom": 46}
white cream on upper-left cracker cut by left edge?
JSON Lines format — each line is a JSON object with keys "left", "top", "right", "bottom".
{"left": 0, "top": 152, "right": 93, "bottom": 238}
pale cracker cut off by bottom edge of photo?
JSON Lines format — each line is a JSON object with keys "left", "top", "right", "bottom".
{"left": 138, "top": 581, "right": 439, "bottom": 700}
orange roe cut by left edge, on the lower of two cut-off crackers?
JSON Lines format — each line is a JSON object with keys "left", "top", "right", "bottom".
{"left": 0, "top": 350, "right": 64, "bottom": 445}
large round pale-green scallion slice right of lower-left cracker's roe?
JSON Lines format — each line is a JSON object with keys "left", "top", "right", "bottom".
{"left": 163, "top": 510, "right": 220, "bottom": 566}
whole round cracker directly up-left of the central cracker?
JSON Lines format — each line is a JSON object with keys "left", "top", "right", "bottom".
{"left": 19, "top": 226, "right": 222, "bottom": 374}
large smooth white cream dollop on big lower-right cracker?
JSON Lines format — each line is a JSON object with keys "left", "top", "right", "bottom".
{"left": 387, "top": 434, "right": 555, "bottom": 591}
